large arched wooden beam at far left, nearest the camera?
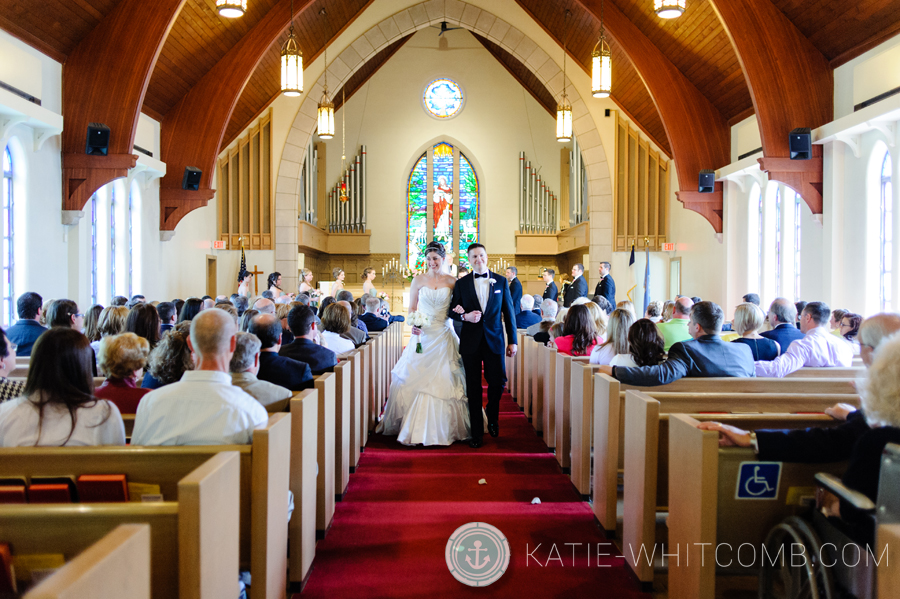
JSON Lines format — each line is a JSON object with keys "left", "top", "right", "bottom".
{"left": 62, "top": 0, "right": 185, "bottom": 210}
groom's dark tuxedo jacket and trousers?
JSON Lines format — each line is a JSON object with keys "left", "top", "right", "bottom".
{"left": 447, "top": 272, "right": 516, "bottom": 441}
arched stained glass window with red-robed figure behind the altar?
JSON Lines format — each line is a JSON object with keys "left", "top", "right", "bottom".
{"left": 406, "top": 142, "right": 481, "bottom": 271}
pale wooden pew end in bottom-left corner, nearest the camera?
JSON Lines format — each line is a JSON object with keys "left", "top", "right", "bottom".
{"left": 25, "top": 524, "right": 150, "bottom": 599}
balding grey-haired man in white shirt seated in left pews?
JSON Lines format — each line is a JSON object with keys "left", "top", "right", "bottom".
{"left": 131, "top": 310, "right": 268, "bottom": 445}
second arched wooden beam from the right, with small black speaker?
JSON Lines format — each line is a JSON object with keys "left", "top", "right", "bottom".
{"left": 579, "top": 0, "right": 731, "bottom": 233}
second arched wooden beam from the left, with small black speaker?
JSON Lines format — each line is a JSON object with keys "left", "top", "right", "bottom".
{"left": 159, "top": 0, "right": 313, "bottom": 231}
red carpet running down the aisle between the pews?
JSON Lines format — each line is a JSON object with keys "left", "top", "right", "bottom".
{"left": 294, "top": 386, "right": 647, "bottom": 599}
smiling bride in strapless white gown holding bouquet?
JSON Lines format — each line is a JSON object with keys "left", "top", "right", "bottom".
{"left": 377, "top": 241, "right": 482, "bottom": 445}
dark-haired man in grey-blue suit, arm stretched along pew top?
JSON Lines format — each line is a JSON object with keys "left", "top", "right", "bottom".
{"left": 599, "top": 298, "right": 755, "bottom": 387}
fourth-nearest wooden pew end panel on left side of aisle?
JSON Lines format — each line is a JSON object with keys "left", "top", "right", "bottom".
{"left": 288, "top": 389, "right": 319, "bottom": 584}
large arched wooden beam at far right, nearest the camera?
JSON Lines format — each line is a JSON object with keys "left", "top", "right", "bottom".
{"left": 710, "top": 0, "right": 834, "bottom": 214}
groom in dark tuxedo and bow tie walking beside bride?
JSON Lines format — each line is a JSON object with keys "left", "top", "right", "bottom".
{"left": 448, "top": 243, "right": 517, "bottom": 448}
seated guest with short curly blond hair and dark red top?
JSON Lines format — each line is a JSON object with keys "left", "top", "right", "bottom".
{"left": 94, "top": 330, "right": 152, "bottom": 414}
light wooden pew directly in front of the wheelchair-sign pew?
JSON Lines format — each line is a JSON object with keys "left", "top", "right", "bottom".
{"left": 622, "top": 391, "right": 856, "bottom": 585}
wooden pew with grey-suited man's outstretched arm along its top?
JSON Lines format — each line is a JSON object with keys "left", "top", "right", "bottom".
{"left": 592, "top": 374, "right": 859, "bottom": 534}
